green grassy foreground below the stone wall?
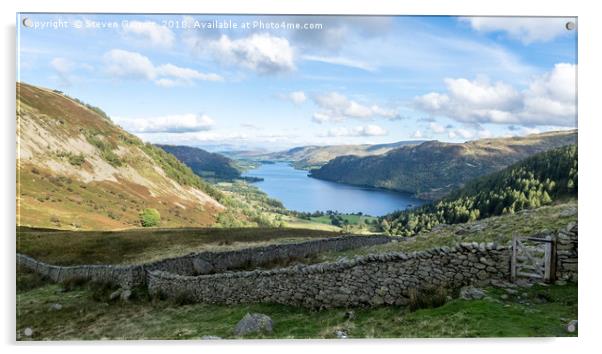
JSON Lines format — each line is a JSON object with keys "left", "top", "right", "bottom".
{"left": 16, "top": 273, "right": 577, "bottom": 340}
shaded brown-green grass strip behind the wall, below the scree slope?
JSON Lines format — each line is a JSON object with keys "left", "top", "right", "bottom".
{"left": 17, "top": 227, "right": 340, "bottom": 265}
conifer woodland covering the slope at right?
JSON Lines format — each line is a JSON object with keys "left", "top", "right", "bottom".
{"left": 380, "top": 145, "right": 577, "bottom": 236}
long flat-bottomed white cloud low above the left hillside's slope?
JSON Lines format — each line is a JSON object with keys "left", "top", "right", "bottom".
{"left": 114, "top": 113, "right": 215, "bottom": 133}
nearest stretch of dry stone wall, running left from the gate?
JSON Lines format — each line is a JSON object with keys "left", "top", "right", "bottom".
{"left": 148, "top": 243, "right": 510, "bottom": 308}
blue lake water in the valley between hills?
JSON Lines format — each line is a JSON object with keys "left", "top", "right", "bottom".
{"left": 245, "top": 163, "right": 424, "bottom": 216}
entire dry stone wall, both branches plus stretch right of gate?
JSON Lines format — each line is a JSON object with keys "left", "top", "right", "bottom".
{"left": 17, "top": 223, "right": 578, "bottom": 308}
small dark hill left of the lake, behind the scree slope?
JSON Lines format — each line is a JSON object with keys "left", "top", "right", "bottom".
{"left": 157, "top": 145, "right": 240, "bottom": 180}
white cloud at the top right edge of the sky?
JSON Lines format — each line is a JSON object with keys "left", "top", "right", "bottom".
{"left": 461, "top": 17, "right": 572, "bottom": 44}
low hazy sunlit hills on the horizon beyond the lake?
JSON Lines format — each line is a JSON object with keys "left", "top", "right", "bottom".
{"left": 247, "top": 140, "right": 425, "bottom": 170}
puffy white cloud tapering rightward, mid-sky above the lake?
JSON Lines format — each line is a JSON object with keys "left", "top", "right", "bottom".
{"left": 312, "top": 92, "right": 399, "bottom": 123}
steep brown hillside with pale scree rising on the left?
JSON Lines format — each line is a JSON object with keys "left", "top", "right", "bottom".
{"left": 17, "top": 83, "right": 224, "bottom": 230}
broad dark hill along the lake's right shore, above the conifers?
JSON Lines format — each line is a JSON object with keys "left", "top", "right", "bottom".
{"left": 310, "top": 130, "right": 577, "bottom": 199}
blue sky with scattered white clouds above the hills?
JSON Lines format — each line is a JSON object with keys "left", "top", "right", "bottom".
{"left": 17, "top": 14, "right": 577, "bottom": 150}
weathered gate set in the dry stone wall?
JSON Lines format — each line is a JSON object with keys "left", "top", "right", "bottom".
{"left": 510, "top": 236, "right": 556, "bottom": 283}
